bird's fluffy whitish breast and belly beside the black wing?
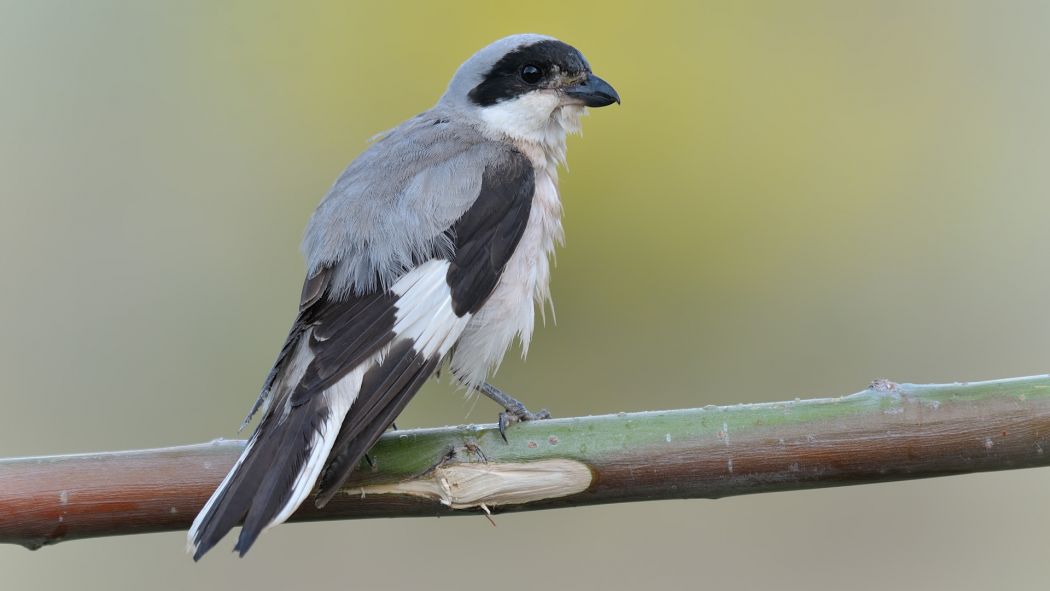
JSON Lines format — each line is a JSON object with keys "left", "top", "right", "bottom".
{"left": 450, "top": 163, "right": 564, "bottom": 386}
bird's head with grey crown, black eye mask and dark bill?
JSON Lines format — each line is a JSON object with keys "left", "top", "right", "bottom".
{"left": 441, "top": 35, "right": 620, "bottom": 144}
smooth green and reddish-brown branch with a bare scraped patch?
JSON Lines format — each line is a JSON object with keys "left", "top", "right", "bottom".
{"left": 0, "top": 376, "right": 1050, "bottom": 549}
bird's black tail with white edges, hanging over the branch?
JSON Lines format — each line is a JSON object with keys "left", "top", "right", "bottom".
{"left": 180, "top": 367, "right": 364, "bottom": 561}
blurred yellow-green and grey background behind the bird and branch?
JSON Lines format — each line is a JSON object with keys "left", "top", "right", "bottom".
{"left": 0, "top": 0, "right": 1050, "bottom": 590}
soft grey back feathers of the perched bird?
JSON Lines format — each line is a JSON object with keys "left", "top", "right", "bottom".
{"left": 302, "top": 115, "right": 506, "bottom": 293}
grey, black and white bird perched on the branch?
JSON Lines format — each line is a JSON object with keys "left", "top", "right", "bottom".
{"left": 188, "top": 34, "right": 621, "bottom": 561}
